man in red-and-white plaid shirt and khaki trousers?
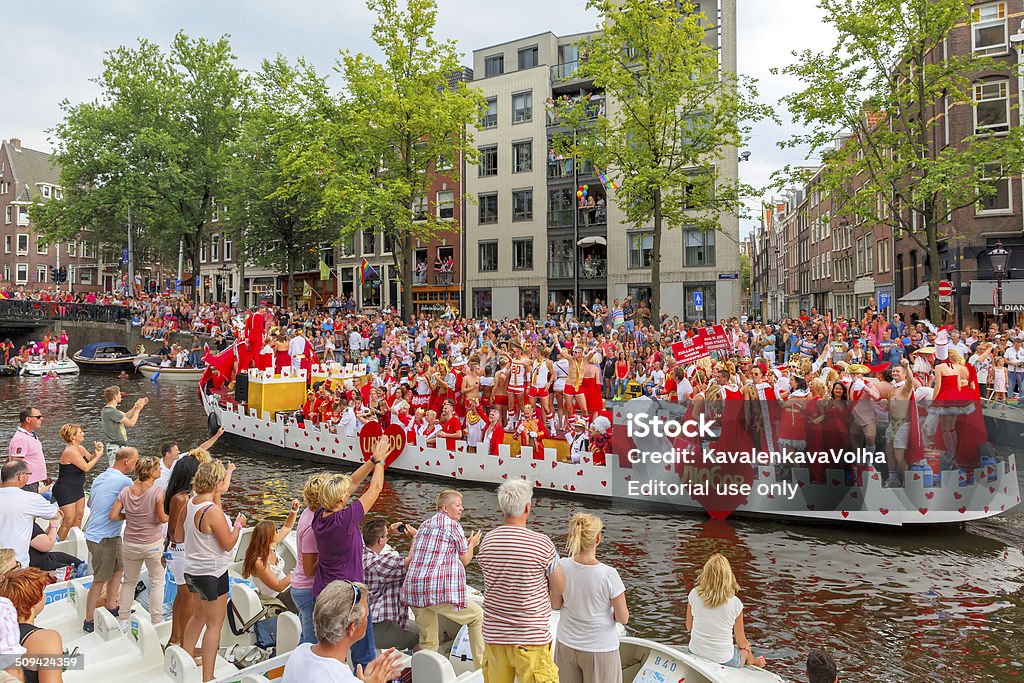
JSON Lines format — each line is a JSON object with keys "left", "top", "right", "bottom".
{"left": 401, "top": 489, "right": 483, "bottom": 669}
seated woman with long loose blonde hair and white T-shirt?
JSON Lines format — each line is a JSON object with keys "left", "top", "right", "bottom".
{"left": 686, "top": 553, "right": 765, "bottom": 669}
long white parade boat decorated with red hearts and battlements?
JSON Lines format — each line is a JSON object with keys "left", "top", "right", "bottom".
{"left": 200, "top": 366, "right": 1020, "bottom": 526}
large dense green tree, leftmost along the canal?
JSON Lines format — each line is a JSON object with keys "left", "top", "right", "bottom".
{"left": 36, "top": 33, "right": 248, "bottom": 296}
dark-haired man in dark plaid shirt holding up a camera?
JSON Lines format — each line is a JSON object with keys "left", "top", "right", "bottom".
{"left": 362, "top": 518, "right": 420, "bottom": 650}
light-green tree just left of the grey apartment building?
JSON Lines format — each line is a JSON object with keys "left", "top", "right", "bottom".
{"left": 293, "top": 0, "right": 483, "bottom": 316}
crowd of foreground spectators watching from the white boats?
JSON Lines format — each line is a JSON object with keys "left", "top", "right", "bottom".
{"left": 0, "top": 417, "right": 837, "bottom": 683}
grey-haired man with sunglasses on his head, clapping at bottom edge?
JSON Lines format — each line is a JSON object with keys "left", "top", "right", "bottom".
{"left": 281, "top": 581, "right": 401, "bottom": 683}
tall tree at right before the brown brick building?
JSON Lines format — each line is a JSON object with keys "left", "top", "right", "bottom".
{"left": 774, "top": 0, "right": 1024, "bottom": 321}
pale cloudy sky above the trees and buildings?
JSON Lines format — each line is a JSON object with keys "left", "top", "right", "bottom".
{"left": 0, "top": 0, "right": 834, "bottom": 239}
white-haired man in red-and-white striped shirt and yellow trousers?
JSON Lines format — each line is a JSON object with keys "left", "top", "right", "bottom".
{"left": 477, "top": 479, "right": 565, "bottom": 683}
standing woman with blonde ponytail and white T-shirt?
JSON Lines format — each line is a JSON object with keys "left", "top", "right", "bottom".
{"left": 551, "top": 513, "right": 630, "bottom": 683}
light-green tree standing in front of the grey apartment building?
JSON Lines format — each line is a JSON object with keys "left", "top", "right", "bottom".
{"left": 555, "top": 0, "right": 770, "bottom": 321}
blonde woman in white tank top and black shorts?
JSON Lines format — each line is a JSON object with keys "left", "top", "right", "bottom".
{"left": 181, "top": 460, "right": 246, "bottom": 681}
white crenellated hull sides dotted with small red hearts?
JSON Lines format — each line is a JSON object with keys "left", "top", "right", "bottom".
{"left": 204, "top": 395, "right": 1020, "bottom": 526}
